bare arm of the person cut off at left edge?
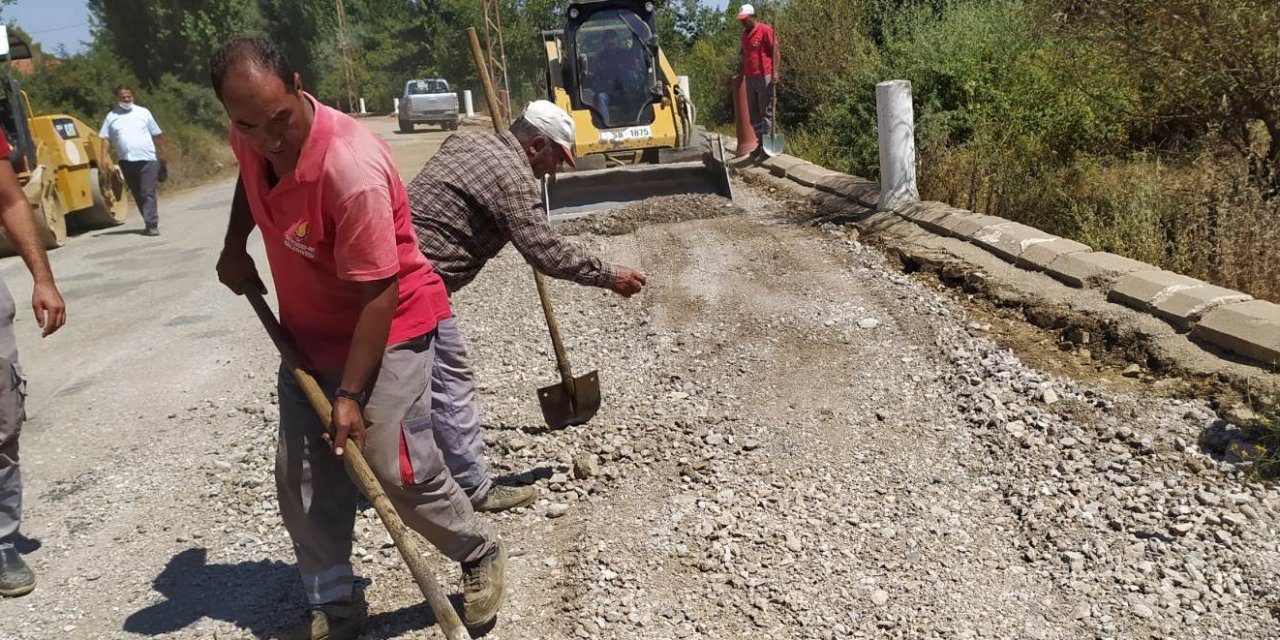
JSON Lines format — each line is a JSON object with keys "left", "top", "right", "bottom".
{"left": 0, "top": 161, "right": 67, "bottom": 337}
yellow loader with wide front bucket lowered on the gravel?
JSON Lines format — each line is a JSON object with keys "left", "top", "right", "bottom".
{"left": 543, "top": 0, "right": 733, "bottom": 221}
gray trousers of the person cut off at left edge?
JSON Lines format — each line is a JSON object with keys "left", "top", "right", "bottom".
{"left": 0, "top": 282, "right": 27, "bottom": 547}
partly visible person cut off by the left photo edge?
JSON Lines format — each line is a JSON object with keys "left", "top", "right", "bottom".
{"left": 0, "top": 127, "right": 67, "bottom": 598}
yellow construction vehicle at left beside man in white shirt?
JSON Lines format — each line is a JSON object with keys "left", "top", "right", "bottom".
{"left": 0, "top": 24, "right": 128, "bottom": 255}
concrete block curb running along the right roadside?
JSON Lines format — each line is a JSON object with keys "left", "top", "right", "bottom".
{"left": 730, "top": 154, "right": 1280, "bottom": 369}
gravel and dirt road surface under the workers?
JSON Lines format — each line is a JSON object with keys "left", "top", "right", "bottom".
{"left": 0, "top": 120, "right": 1280, "bottom": 640}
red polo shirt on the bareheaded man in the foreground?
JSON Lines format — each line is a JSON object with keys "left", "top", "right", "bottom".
{"left": 230, "top": 95, "right": 453, "bottom": 370}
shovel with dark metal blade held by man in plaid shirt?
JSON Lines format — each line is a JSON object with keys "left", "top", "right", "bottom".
{"left": 467, "top": 27, "right": 600, "bottom": 429}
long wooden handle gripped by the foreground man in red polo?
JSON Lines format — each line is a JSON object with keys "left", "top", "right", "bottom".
{"left": 244, "top": 289, "right": 471, "bottom": 640}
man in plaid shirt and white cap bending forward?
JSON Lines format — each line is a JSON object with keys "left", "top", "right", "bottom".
{"left": 408, "top": 100, "right": 645, "bottom": 512}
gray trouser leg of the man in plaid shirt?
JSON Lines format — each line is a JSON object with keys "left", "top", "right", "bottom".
{"left": 431, "top": 317, "right": 493, "bottom": 506}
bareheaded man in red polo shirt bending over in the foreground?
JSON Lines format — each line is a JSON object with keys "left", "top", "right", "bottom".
{"left": 210, "top": 37, "right": 507, "bottom": 639}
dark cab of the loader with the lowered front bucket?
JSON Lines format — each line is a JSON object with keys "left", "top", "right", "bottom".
{"left": 561, "top": 0, "right": 666, "bottom": 129}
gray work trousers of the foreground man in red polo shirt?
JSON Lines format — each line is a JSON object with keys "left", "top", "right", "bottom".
{"left": 275, "top": 332, "right": 498, "bottom": 604}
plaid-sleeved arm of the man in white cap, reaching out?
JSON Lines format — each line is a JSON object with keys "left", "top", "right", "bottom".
{"left": 489, "top": 174, "right": 645, "bottom": 297}
